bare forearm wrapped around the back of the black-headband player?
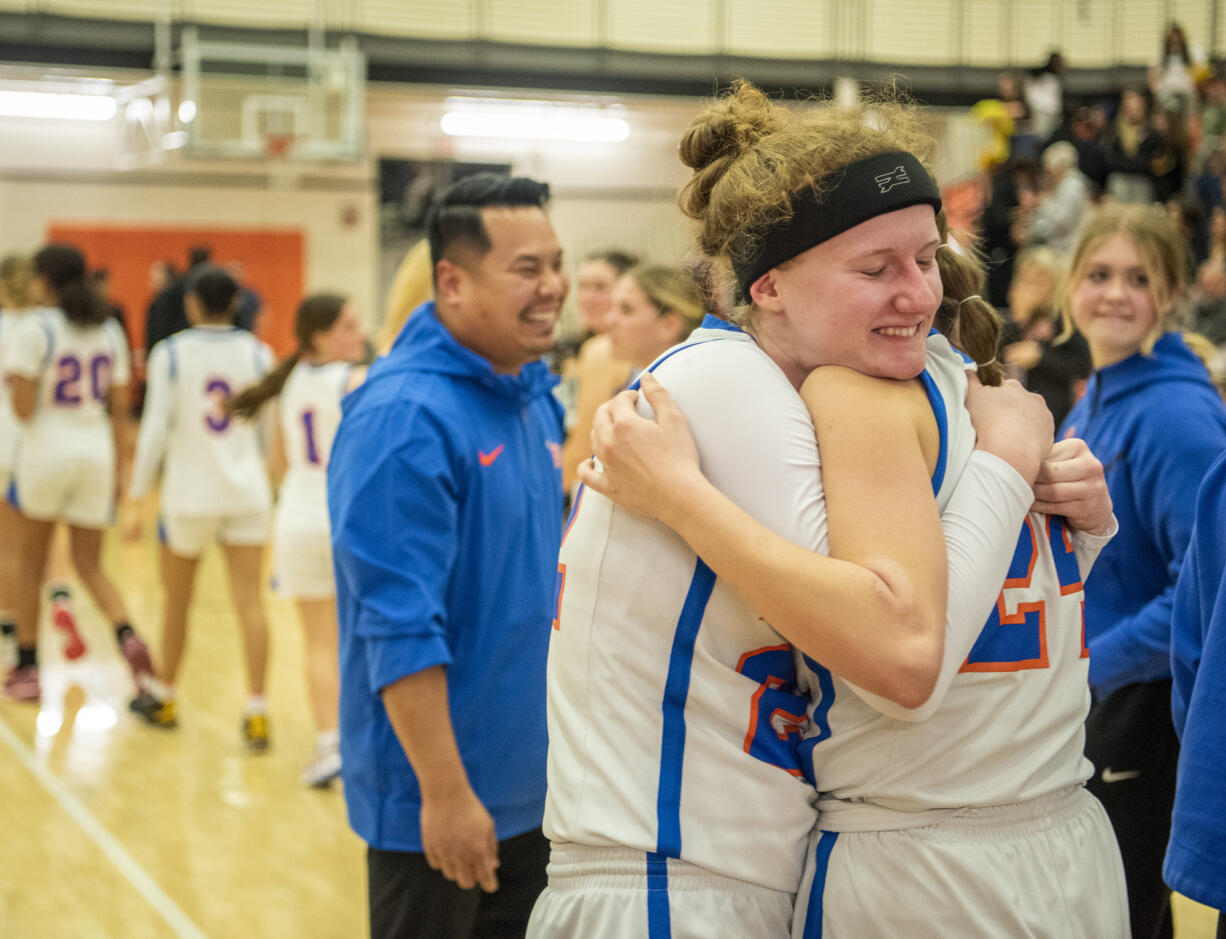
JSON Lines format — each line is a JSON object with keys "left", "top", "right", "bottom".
{"left": 664, "top": 479, "right": 943, "bottom": 706}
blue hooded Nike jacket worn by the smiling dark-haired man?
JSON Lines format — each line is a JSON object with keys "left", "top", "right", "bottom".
{"left": 327, "top": 303, "right": 562, "bottom": 852}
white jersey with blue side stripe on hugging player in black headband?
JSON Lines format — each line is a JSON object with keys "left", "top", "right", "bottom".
{"left": 544, "top": 320, "right": 825, "bottom": 892}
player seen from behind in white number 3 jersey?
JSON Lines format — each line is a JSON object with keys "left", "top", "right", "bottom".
{"left": 129, "top": 266, "right": 272, "bottom": 750}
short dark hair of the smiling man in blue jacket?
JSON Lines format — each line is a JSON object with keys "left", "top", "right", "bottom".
{"left": 425, "top": 173, "right": 549, "bottom": 283}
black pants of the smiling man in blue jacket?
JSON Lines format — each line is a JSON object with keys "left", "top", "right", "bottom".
{"left": 367, "top": 829, "right": 549, "bottom": 939}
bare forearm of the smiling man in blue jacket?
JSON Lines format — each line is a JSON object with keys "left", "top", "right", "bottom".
{"left": 383, "top": 666, "right": 470, "bottom": 800}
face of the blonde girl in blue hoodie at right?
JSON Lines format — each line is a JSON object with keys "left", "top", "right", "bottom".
{"left": 1069, "top": 234, "right": 1168, "bottom": 369}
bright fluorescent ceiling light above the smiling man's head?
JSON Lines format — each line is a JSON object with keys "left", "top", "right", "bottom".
{"left": 440, "top": 98, "right": 630, "bottom": 143}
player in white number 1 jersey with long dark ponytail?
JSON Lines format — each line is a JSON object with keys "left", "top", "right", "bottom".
{"left": 228, "top": 293, "right": 365, "bottom": 787}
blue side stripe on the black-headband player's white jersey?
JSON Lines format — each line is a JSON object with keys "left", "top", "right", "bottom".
{"left": 656, "top": 558, "right": 715, "bottom": 858}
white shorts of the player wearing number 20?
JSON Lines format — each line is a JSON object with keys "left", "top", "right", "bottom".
{"left": 7, "top": 458, "right": 115, "bottom": 528}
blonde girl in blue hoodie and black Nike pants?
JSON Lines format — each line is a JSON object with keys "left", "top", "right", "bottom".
{"left": 1060, "top": 206, "right": 1226, "bottom": 939}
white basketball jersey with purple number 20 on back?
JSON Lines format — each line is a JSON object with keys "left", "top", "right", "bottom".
{"left": 4, "top": 308, "right": 131, "bottom": 460}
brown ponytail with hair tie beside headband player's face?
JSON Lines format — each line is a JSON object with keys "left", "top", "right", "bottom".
{"left": 935, "top": 224, "right": 1004, "bottom": 386}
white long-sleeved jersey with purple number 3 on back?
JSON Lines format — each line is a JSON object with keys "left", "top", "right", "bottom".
{"left": 131, "top": 326, "right": 272, "bottom": 516}
